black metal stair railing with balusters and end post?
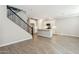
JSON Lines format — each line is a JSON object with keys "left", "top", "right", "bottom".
{"left": 7, "top": 6, "right": 33, "bottom": 36}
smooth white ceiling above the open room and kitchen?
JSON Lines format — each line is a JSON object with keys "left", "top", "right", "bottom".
{"left": 14, "top": 5, "right": 79, "bottom": 18}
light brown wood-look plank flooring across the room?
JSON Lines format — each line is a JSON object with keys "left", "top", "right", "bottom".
{"left": 0, "top": 35, "right": 79, "bottom": 54}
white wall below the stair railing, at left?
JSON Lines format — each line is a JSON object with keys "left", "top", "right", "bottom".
{"left": 0, "top": 5, "right": 32, "bottom": 47}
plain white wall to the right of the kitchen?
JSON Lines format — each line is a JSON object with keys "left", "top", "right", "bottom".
{"left": 56, "top": 16, "right": 79, "bottom": 37}
